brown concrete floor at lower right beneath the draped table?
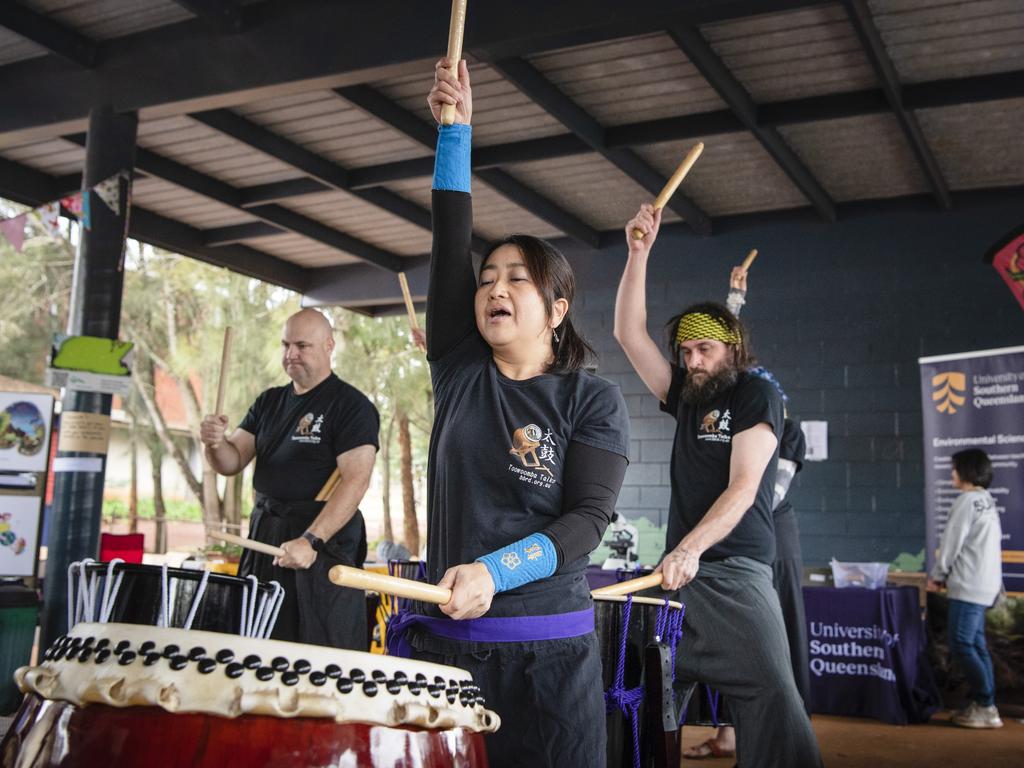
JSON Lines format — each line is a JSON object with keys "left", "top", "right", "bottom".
{"left": 680, "top": 713, "right": 1024, "bottom": 768}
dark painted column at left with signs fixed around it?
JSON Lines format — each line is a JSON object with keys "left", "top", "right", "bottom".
{"left": 42, "top": 106, "right": 138, "bottom": 647}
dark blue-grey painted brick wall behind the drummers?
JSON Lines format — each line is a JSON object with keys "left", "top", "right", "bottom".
{"left": 567, "top": 190, "right": 1024, "bottom": 564}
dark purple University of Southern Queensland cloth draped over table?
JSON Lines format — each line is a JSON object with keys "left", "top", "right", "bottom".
{"left": 804, "top": 587, "right": 941, "bottom": 725}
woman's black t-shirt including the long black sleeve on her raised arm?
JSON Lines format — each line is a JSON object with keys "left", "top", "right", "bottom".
{"left": 423, "top": 190, "right": 629, "bottom": 616}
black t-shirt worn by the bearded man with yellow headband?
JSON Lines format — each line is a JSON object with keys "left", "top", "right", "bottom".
{"left": 662, "top": 368, "right": 782, "bottom": 564}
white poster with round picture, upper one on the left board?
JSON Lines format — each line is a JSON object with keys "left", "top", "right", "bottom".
{"left": 0, "top": 392, "right": 53, "bottom": 472}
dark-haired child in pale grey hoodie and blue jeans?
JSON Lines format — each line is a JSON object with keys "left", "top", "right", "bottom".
{"left": 928, "top": 449, "right": 1002, "bottom": 728}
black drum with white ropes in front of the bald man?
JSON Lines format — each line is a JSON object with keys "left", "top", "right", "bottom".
{"left": 68, "top": 560, "right": 285, "bottom": 638}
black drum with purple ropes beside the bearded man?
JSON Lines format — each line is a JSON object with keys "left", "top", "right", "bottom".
{"left": 594, "top": 596, "right": 683, "bottom": 768}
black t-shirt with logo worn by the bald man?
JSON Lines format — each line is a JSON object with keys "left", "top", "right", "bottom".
{"left": 239, "top": 374, "right": 380, "bottom": 502}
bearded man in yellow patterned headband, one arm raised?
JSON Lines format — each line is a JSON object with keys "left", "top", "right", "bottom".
{"left": 614, "top": 205, "right": 821, "bottom": 768}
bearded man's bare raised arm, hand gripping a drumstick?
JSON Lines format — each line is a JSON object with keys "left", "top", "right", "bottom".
{"left": 613, "top": 205, "right": 672, "bottom": 402}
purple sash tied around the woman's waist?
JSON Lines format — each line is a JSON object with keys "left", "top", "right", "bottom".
{"left": 387, "top": 608, "right": 594, "bottom": 658}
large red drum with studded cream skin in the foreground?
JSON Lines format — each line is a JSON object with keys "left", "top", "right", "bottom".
{"left": 0, "top": 624, "right": 500, "bottom": 768}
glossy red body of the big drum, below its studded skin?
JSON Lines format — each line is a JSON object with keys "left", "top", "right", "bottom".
{"left": 0, "top": 694, "right": 487, "bottom": 768}
